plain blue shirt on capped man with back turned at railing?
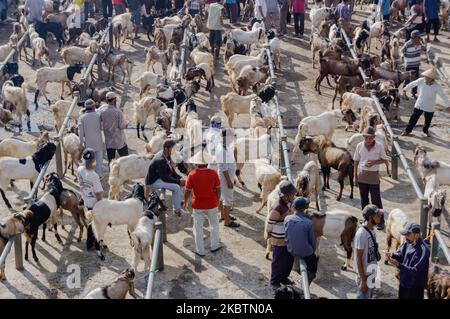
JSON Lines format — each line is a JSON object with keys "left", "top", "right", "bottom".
{"left": 284, "top": 212, "right": 316, "bottom": 258}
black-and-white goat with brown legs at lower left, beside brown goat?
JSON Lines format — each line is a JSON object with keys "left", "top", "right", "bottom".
{"left": 23, "top": 170, "right": 63, "bottom": 262}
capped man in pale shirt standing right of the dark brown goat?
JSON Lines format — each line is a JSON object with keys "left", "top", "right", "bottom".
{"left": 353, "top": 126, "right": 389, "bottom": 230}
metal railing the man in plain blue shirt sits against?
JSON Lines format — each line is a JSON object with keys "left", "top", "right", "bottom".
{"left": 265, "top": 44, "right": 311, "bottom": 299}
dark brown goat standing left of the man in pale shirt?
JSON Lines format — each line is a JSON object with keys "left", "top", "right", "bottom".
{"left": 300, "top": 136, "right": 354, "bottom": 201}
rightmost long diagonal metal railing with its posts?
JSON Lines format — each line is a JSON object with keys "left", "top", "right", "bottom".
{"left": 340, "top": 28, "right": 428, "bottom": 237}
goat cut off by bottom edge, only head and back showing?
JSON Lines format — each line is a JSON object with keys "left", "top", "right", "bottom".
{"left": 83, "top": 269, "right": 137, "bottom": 299}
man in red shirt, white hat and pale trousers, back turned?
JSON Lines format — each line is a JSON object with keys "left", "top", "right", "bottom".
{"left": 184, "top": 151, "right": 222, "bottom": 257}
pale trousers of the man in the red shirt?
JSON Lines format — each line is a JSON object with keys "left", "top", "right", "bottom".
{"left": 192, "top": 207, "right": 220, "bottom": 255}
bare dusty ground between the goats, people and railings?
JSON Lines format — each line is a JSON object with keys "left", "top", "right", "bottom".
{"left": 0, "top": 4, "right": 450, "bottom": 299}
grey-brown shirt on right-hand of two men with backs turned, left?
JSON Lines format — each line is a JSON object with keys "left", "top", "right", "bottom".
{"left": 100, "top": 104, "right": 127, "bottom": 150}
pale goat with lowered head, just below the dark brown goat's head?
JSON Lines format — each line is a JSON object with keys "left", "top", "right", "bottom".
{"left": 295, "top": 161, "right": 320, "bottom": 211}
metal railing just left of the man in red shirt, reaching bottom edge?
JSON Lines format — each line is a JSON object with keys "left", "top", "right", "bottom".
{"left": 145, "top": 30, "right": 187, "bottom": 299}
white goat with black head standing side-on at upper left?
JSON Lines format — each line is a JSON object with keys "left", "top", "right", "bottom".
{"left": 34, "top": 64, "right": 83, "bottom": 110}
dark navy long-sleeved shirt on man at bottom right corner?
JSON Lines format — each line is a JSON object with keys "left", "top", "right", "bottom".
{"left": 392, "top": 238, "right": 430, "bottom": 288}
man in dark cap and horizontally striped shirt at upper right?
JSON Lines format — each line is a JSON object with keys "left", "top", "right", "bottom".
{"left": 400, "top": 30, "right": 426, "bottom": 99}
